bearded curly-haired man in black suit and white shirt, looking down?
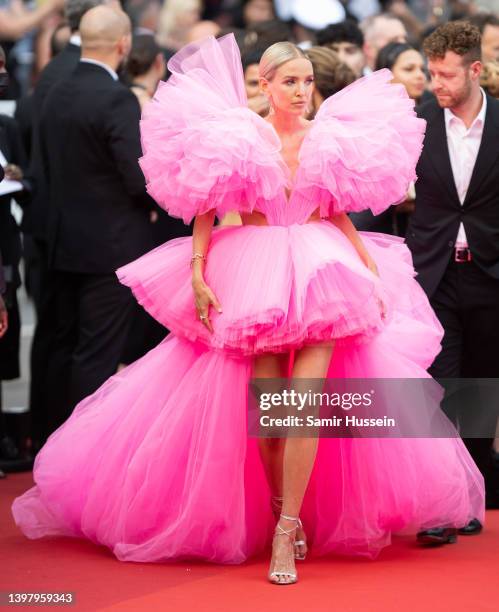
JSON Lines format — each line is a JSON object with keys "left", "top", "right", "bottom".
{"left": 407, "top": 22, "right": 499, "bottom": 543}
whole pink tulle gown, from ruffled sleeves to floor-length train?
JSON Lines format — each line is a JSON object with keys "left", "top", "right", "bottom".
{"left": 12, "top": 36, "right": 484, "bottom": 563}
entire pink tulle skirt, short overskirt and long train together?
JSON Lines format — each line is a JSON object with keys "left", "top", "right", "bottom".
{"left": 13, "top": 222, "right": 484, "bottom": 563}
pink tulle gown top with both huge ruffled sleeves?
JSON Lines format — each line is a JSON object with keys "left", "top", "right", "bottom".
{"left": 140, "top": 35, "right": 425, "bottom": 225}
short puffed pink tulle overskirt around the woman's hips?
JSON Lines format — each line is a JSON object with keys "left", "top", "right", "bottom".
{"left": 117, "top": 222, "right": 440, "bottom": 355}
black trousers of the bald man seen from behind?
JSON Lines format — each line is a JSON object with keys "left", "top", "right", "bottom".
{"left": 47, "top": 272, "right": 133, "bottom": 431}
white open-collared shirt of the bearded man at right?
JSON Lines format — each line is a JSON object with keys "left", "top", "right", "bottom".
{"left": 444, "top": 89, "right": 487, "bottom": 247}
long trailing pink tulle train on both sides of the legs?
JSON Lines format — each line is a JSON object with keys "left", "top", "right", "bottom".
{"left": 13, "top": 332, "right": 483, "bottom": 563}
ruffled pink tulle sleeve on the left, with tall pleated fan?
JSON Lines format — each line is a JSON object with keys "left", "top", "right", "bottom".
{"left": 140, "top": 34, "right": 285, "bottom": 223}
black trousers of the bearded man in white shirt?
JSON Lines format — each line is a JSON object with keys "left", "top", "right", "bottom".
{"left": 429, "top": 260, "right": 499, "bottom": 504}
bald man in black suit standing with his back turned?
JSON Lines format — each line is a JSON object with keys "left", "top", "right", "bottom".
{"left": 40, "top": 5, "right": 152, "bottom": 436}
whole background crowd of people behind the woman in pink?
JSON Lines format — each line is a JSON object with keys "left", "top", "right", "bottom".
{"left": 0, "top": 0, "right": 499, "bottom": 507}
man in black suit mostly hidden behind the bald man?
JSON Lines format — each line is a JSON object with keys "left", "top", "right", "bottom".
{"left": 27, "top": 0, "right": 119, "bottom": 451}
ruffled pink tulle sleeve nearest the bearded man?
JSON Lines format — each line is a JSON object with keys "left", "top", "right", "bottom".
{"left": 297, "top": 69, "right": 426, "bottom": 217}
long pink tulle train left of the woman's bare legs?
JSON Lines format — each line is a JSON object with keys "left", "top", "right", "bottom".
{"left": 13, "top": 336, "right": 269, "bottom": 563}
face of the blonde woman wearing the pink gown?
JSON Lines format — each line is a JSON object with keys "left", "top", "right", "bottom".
{"left": 260, "top": 57, "right": 314, "bottom": 115}
